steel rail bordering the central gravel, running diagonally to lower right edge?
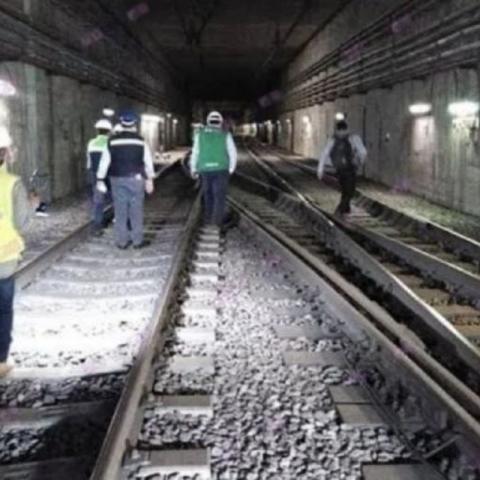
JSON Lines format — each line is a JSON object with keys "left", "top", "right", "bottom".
{"left": 229, "top": 197, "right": 480, "bottom": 462}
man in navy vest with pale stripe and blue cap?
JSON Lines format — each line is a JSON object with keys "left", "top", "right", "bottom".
{"left": 97, "top": 112, "right": 155, "bottom": 250}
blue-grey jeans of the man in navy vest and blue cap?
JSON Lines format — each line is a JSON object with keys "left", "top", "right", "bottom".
{"left": 110, "top": 177, "right": 145, "bottom": 247}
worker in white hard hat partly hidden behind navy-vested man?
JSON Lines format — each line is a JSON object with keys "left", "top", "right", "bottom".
{"left": 87, "top": 118, "right": 113, "bottom": 236}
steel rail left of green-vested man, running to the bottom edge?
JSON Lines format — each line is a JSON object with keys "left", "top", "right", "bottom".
{"left": 90, "top": 193, "right": 201, "bottom": 480}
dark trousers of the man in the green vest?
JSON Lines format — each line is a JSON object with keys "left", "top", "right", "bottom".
{"left": 200, "top": 171, "right": 230, "bottom": 227}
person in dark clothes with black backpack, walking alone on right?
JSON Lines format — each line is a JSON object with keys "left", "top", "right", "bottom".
{"left": 317, "top": 120, "right": 367, "bottom": 217}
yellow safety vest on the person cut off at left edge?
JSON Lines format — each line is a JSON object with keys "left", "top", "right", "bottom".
{"left": 0, "top": 168, "right": 25, "bottom": 263}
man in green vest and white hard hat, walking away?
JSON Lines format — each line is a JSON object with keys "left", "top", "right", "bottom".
{"left": 190, "top": 112, "right": 237, "bottom": 227}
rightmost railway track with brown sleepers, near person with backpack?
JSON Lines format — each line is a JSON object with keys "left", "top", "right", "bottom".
{"left": 237, "top": 145, "right": 480, "bottom": 376}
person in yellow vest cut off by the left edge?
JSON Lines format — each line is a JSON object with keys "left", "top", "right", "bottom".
{"left": 0, "top": 127, "right": 39, "bottom": 377}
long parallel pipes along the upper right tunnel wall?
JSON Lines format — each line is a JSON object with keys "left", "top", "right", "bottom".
{"left": 284, "top": 2, "right": 480, "bottom": 110}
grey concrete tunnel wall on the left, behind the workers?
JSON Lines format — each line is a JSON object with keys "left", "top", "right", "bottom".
{"left": 0, "top": 62, "right": 185, "bottom": 202}
